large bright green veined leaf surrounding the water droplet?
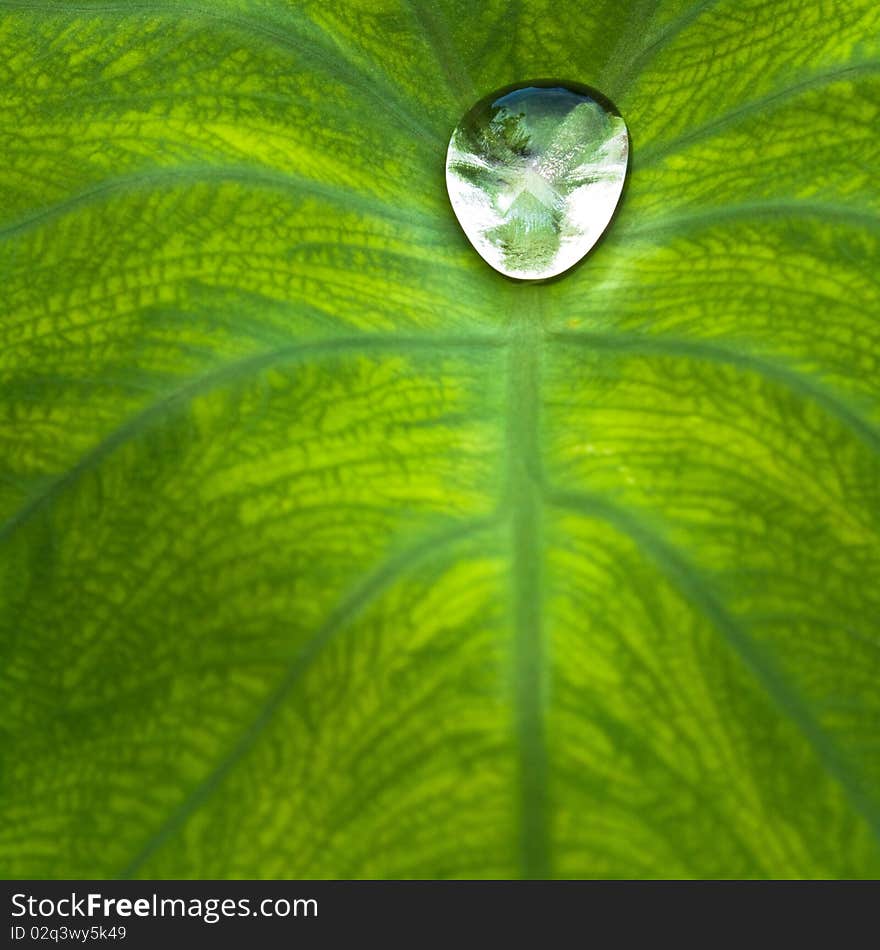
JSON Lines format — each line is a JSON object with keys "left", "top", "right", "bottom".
{"left": 0, "top": 0, "right": 880, "bottom": 878}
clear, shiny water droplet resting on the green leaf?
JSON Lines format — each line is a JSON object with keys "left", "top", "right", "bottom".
{"left": 446, "top": 80, "right": 629, "bottom": 280}
